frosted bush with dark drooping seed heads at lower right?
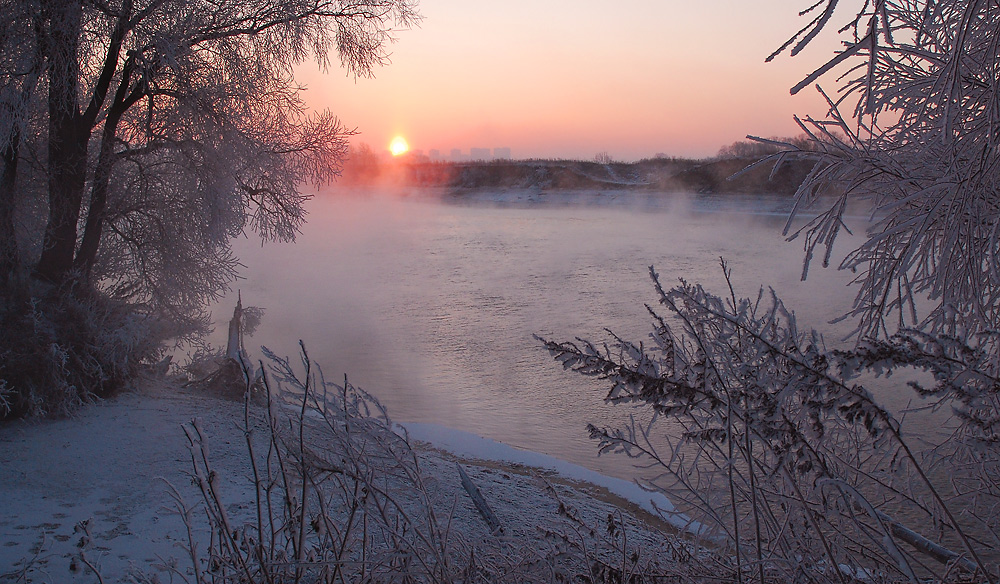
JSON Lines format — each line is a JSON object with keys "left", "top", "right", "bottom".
{"left": 545, "top": 269, "right": 1000, "bottom": 581}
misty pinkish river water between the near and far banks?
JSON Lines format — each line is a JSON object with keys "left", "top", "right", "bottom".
{"left": 214, "top": 189, "right": 868, "bottom": 478}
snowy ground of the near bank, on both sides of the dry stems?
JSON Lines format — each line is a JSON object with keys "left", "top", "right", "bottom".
{"left": 0, "top": 382, "right": 708, "bottom": 582}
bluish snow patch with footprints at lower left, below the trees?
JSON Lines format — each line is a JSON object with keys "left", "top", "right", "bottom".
{"left": 0, "top": 378, "right": 254, "bottom": 582}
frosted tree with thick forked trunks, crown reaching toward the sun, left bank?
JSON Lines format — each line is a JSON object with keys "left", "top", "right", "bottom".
{"left": 22, "top": 0, "right": 416, "bottom": 283}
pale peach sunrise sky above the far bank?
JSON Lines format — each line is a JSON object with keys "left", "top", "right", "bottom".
{"left": 297, "top": 0, "right": 847, "bottom": 161}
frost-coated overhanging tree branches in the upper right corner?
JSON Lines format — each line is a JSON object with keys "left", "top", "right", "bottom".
{"left": 772, "top": 0, "right": 1000, "bottom": 337}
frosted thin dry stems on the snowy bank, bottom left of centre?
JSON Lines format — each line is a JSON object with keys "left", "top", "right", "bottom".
{"left": 161, "top": 347, "right": 477, "bottom": 584}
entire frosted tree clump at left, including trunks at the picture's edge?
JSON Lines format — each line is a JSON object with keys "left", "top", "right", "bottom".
{"left": 0, "top": 0, "right": 419, "bottom": 420}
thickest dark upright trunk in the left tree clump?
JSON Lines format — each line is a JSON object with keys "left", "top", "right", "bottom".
{"left": 35, "top": 0, "right": 90, "bottom": 284}
